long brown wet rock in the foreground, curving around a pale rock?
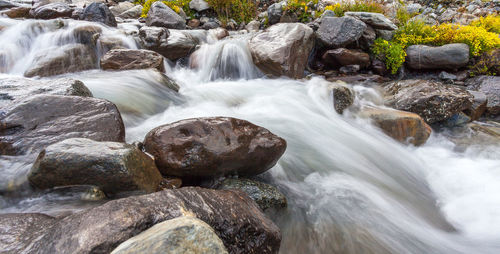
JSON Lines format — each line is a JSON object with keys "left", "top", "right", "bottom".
{"left": 0, "top": 188, "right": 281, "bottom": 254}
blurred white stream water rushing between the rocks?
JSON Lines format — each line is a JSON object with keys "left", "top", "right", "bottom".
{"left": 0, "top": 18, "right": 500, "bottom": 253}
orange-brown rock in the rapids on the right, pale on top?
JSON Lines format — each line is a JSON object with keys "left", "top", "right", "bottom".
{"left": 360, "top": 108, "right": 432, "bottom": 146}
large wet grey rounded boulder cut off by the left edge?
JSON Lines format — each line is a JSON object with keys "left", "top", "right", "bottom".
{"left": 0, "top": 95, "right": 125, "bottom": 155}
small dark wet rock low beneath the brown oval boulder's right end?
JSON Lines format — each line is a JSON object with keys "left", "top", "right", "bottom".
{"left": 217, "top": 178, "right": 287, "bottom": 211}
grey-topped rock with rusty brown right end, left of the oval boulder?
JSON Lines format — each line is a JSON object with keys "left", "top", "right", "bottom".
{"left": 28, "top": 138, "right": 163, "bottom": 194}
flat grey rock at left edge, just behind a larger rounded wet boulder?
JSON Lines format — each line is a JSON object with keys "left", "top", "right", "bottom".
{"left": 0, "top": 77, "right": 92, "bottom": 108}
